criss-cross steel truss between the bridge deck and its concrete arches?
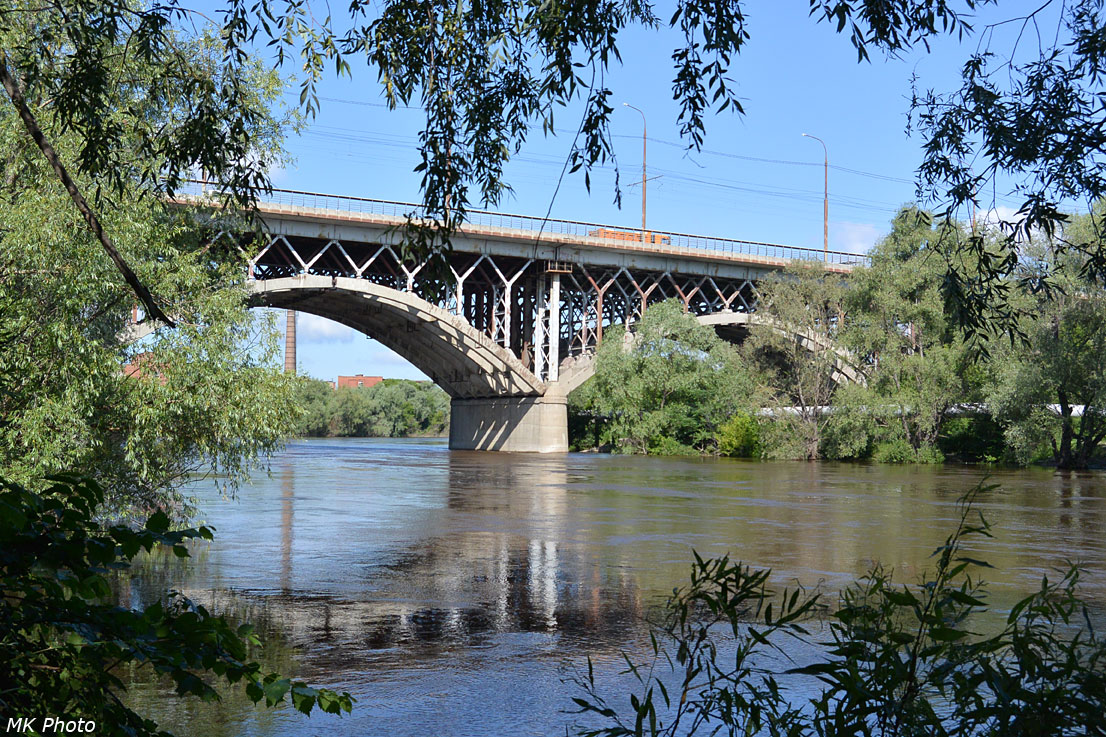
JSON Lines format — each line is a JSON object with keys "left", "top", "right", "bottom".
{"left": 249, "top": 236, "right": 758, "bottom": 382}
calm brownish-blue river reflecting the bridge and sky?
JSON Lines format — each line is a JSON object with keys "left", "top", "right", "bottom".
{"left": 133, "top": 439, "right": 1106, "bottom": 737}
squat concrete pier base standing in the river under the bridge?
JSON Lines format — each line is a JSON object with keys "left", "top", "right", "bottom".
{"left": 449, "top": 396, "right": 568, "bottom": 453}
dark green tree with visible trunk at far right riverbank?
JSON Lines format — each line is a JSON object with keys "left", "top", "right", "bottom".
{"left": 987, "top": 215, "right": 1106, "bottom": 468}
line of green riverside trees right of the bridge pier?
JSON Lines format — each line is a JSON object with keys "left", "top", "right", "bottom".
{"left": 570, "top": 208, "right": 1106, "bottom": 468}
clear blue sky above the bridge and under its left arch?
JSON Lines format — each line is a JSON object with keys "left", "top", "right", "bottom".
{"left": 265, "top": 2, "right": 1030, "bottom": 380}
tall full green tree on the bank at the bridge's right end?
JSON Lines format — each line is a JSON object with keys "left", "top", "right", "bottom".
{"left": 832, "top": 208, "right": 973, "bottom": 460}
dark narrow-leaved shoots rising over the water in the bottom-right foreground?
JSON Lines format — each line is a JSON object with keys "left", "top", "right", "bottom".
{"left": 574, "top": 487, "right": 1106, "bottom": 737}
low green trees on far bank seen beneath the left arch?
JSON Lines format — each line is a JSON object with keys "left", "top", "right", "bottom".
{"left": 298, "top": 378, "right": 449, "bottom": 437}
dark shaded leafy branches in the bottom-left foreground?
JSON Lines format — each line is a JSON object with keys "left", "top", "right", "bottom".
{"left": 0, "top": 476, "right": 353, "bottom": 735}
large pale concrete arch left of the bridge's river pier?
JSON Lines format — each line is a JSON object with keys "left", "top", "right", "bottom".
{"left": 249, "top": 274, "right": 546, "bottom": 399}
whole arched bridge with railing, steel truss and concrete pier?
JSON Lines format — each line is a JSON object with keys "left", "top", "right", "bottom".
{"left": 196, "top": 183, "right": 866, "bottom": 453}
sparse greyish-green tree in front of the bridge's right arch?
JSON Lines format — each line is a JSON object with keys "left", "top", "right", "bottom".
{"left": 742, "top": 262, "right": 848, "bottom": 459}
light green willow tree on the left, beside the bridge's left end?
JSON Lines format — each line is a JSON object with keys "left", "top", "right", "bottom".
{"left": 0, "top": 35, "right": 294, "bottom": 513}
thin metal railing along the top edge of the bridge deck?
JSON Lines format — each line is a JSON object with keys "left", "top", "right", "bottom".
{"left": 180, "top": 181, "right": 870, "bottom": 266}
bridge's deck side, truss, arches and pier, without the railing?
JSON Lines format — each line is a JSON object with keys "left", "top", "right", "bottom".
{"left": 237, "top": 220, "right": 858, "bottom": 453}
